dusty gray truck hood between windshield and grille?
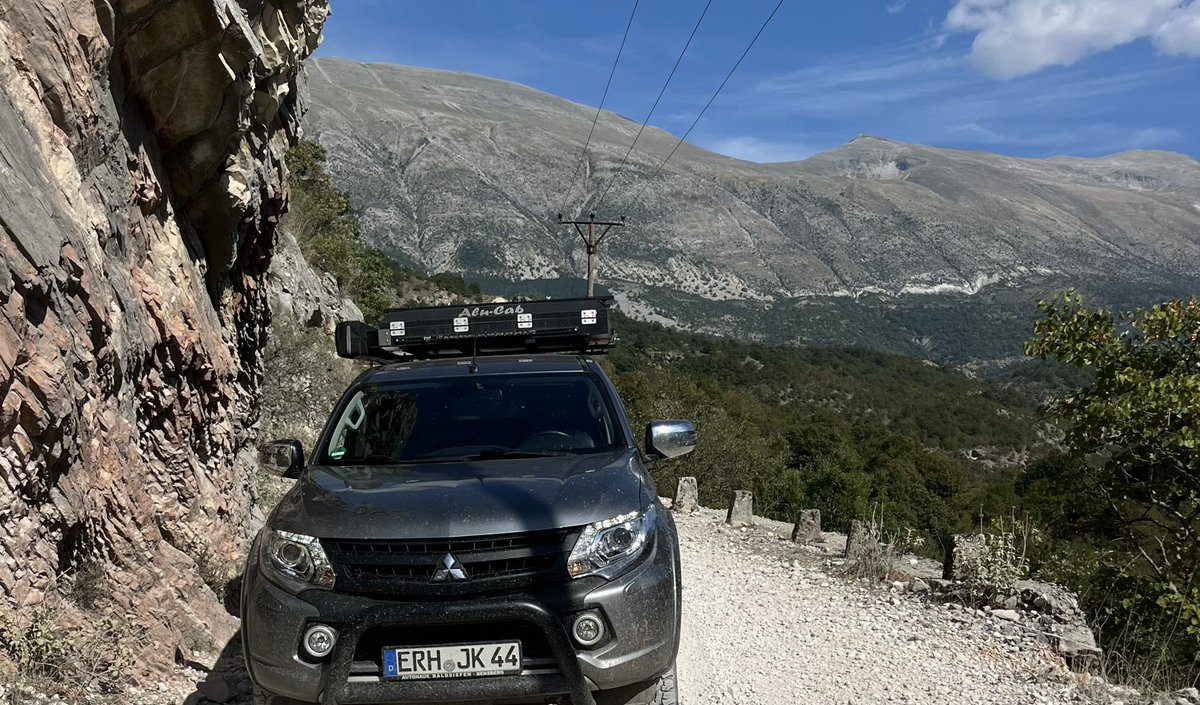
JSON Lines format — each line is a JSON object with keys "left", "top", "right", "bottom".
{"left": 269, "top": 448, "right": 649, "bottom": 538}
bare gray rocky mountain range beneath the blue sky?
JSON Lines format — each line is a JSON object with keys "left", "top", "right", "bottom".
{"left": 306, "top": 59, "right": 1200, "bottom": 353}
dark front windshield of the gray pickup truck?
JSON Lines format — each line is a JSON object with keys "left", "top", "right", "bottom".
{"left": 318, "top": 373, "right": 623, "bottom": 465}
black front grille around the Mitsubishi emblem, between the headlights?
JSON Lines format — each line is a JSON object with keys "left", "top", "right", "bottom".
{"left": 322, "top": 529, "right": 577, "bottom": 597}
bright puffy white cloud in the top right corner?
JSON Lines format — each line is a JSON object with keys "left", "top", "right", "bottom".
{"left": 946, "top": 0, "right": 1200, "bottom": 78}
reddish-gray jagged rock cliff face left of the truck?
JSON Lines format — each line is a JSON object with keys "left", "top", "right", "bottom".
{"left": 0, "top": 0, "right": 328, "bottom": 658}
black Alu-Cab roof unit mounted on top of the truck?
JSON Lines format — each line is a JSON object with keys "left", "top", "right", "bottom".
{"left": 335, "top": 296, "right": 617, "bottom": 362}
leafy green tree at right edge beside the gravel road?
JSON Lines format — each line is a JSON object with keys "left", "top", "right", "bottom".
{"left": 1026, "top": 291, "right": 1200, "bottom": 677}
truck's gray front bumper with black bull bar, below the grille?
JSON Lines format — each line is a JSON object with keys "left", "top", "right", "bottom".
{"left": 242, "top": 519, "right": 679, "bottom": 705}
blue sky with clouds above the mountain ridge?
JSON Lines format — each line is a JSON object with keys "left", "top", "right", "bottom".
{"left": 317, "top": 0, "right": 1200, "bottom": 162}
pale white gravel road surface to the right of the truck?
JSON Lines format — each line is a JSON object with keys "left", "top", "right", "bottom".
{"left": 676, "top": 510, "right": 1108, "bottom": 705}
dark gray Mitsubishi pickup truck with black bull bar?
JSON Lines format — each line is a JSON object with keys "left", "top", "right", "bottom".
{"left": 241, "top": 300, "right": 696, "bottom": 705}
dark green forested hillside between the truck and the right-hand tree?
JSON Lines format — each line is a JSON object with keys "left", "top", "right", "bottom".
{"left": 605, "top": 317, "right": 1051, "bottom": 555}
